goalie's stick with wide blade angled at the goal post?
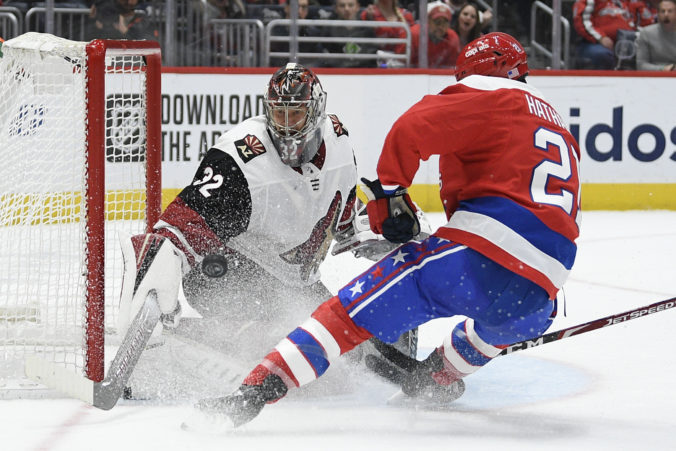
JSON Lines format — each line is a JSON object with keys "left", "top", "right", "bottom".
{"left": 25, "top": 292, "right": 161, "bottom": 410}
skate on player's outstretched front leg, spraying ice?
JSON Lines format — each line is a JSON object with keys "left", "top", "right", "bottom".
{"left": 181, "top": 374, "right": 288, "bottom": 432}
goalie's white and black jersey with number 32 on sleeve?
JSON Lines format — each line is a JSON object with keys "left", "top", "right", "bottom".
{"left": 156, "top": 115, "right": 357, "bottom": 286}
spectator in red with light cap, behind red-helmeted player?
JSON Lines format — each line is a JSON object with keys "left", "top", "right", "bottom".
{"left": 411, "top": 1, "right": 460, "bottom": 69}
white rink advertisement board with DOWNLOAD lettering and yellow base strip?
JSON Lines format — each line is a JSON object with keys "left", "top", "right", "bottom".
{"left": 162, "top": 69, "right": 676, "bottom": 210}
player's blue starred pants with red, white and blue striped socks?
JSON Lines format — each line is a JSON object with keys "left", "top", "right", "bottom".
{"left": 254, "top": 235, "right": 555, "bottom": 386}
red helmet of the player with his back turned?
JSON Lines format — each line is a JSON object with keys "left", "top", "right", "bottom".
{"left": 455, "top": 32, "right": 528, "bottom": 81}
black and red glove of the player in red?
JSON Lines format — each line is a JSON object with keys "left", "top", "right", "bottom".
{"left": 361, "top": 178, "right": 420, "bottom": 243}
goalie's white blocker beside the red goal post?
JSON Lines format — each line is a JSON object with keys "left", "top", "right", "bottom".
{"left": 118, "top": 233, "right": 184, "bottom": 335}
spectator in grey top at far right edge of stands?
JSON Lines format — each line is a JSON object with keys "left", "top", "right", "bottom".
{"left": 636, "top": 0, "right": 676, "bottom": 71}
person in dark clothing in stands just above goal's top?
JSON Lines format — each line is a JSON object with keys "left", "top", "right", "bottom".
{"left": 87, "top": 0, "right": 159, "bottom": 39}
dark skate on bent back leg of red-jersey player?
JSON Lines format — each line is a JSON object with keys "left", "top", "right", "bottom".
{"left": 364, "top": 338, "right": 465, "bottom": 403}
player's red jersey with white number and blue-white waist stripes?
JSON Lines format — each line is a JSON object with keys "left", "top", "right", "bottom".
{"left": 378, "top": 75, "right": 580, "bottom": 299}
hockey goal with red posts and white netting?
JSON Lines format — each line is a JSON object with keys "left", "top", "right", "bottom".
{"left": 0, "top": 33, "right": 161, "bottom": 397}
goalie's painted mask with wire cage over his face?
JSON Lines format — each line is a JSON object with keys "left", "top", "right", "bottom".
{"left": 263, "top": 63, "right": 326, "bottom": 167}
